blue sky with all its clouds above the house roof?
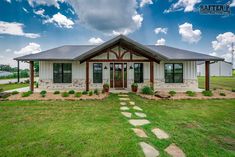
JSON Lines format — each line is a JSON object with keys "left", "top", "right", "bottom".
{"left": 0, "top": 0, "right": 235, "bottom": 67}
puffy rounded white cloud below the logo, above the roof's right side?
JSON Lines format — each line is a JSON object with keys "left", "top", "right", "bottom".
{"left": 179, "top": 22, "right": 202, "bottom": 43}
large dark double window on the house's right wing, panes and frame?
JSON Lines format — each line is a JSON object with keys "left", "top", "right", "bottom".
{"left": 165, "top": 63, "right": 183, "bottom": 83}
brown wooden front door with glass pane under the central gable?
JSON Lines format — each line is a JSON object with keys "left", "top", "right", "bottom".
{"left": 114, "top": 63, "right": 123, "bottom": 88}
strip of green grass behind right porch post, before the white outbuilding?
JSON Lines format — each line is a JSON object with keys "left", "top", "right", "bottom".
{"left": 198, "top": 76, "right": 235, "bottom": 90}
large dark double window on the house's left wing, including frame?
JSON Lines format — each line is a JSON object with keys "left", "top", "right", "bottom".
{"left": 53, "top": 63, "right": 72, "bottom": 83}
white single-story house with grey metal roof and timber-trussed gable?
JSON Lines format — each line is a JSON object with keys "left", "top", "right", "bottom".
{"left": 15, "top": 35, "right": 224, "bottom": 91}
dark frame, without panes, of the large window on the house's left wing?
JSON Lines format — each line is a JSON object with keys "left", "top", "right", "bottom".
{"left": 53, "top": 63, "right": 73, "bottom": 83}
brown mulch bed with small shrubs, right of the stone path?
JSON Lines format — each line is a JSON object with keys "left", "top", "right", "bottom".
{"left": 138, "top": 90, "right": 235, "bottom": 100}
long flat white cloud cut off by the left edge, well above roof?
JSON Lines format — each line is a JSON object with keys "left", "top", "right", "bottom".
{"left": 0, "top": 21, "right": 40, "bottom": 38}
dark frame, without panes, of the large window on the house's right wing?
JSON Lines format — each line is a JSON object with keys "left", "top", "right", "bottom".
{"left": 164, "top": 63, "right": 184, "bottom": 83}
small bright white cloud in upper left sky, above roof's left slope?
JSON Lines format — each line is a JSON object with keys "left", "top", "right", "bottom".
{"left": 44, "top": 13, "right": 74, "bottom": 28}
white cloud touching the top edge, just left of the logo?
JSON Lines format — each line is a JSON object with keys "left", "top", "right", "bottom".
{"left": 164, "top": 0, "right": 201, "bottom": 13}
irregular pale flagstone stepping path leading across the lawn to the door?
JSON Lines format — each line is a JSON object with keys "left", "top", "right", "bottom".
{"left": 118, "top": 94, "right": 186, "bottom": 157}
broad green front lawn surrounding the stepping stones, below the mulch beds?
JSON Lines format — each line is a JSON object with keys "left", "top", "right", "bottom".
{"left": 0, "top": 94, "right": 235, "bottom": 157}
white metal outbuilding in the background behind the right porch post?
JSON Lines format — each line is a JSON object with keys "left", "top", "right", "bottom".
{"left": 197, "top": 61, "right": 233, "bottom": 76}
